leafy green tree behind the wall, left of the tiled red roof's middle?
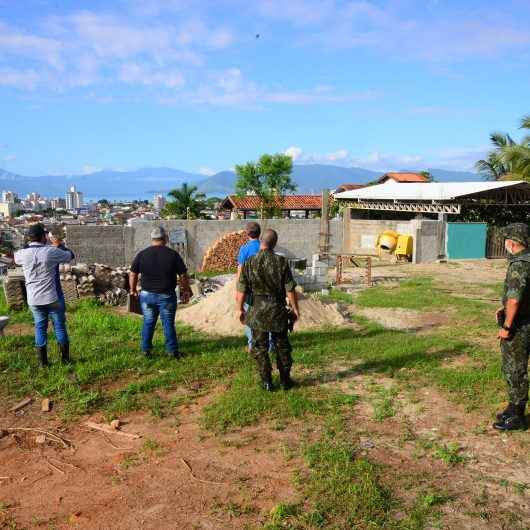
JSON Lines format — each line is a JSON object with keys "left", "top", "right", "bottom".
{"left": 236, "top": 153, "right": 296, "bottom": 219}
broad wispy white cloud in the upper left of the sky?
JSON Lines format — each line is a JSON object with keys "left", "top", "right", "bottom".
{"left": 0, "top": 10, "right": 233, "bottom": 91}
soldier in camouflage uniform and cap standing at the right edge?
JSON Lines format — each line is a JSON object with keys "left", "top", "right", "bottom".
{"left": 493, "top": 223, "right": 530, "bottom": 431}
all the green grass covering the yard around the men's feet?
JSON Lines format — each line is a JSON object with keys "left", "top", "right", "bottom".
{"left": 0, "top": 272, "right": 510, "bottom": 530}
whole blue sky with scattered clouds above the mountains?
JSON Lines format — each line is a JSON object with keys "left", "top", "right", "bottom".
{"left": 0, "top": 0, "right": 530, "bottom": 175}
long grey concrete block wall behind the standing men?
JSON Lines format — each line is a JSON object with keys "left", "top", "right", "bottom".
{"left": 66, "top": 219, "right": 343, "bottom": 270}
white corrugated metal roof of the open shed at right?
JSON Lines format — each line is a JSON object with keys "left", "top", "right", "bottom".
{"left": 335, "top": 180, "right": 530, "bottom": 201}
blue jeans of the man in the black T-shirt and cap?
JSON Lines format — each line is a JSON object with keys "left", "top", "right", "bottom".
{"left": 140, "top": 291, "right": 179, "bottom": 353}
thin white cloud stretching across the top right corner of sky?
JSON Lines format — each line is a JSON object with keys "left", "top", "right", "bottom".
{"left": 256, "top": 0, "right": 530, "bottom": 63}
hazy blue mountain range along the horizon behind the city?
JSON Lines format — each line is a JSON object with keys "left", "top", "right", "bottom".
{"left": 0, "top": 164, "right": 483, "bottom": 200}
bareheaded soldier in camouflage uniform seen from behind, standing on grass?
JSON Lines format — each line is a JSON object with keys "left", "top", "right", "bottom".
{"left": 237, "top": 229, "right": 300, "bottom": 391}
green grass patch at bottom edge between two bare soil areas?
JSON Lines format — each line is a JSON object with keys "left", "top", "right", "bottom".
{"left": 264, "top": 415, "right": 442, "bottom": 530}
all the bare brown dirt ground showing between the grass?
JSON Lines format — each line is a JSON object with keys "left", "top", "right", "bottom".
{"left": 0, "top": 261, "right": 530, "bottom": 530}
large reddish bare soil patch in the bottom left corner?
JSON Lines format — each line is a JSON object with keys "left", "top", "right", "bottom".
{"left": 0, "top": 390, "right": 300, "bottom": 530}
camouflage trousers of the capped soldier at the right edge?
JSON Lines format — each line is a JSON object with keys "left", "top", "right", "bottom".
{"left": 501, "top": 324, "right": 530, "bottom": 405}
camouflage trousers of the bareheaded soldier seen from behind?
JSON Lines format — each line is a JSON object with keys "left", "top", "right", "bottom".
{"left": 250, "top": 329, "right": 293, "bottom": 380}
